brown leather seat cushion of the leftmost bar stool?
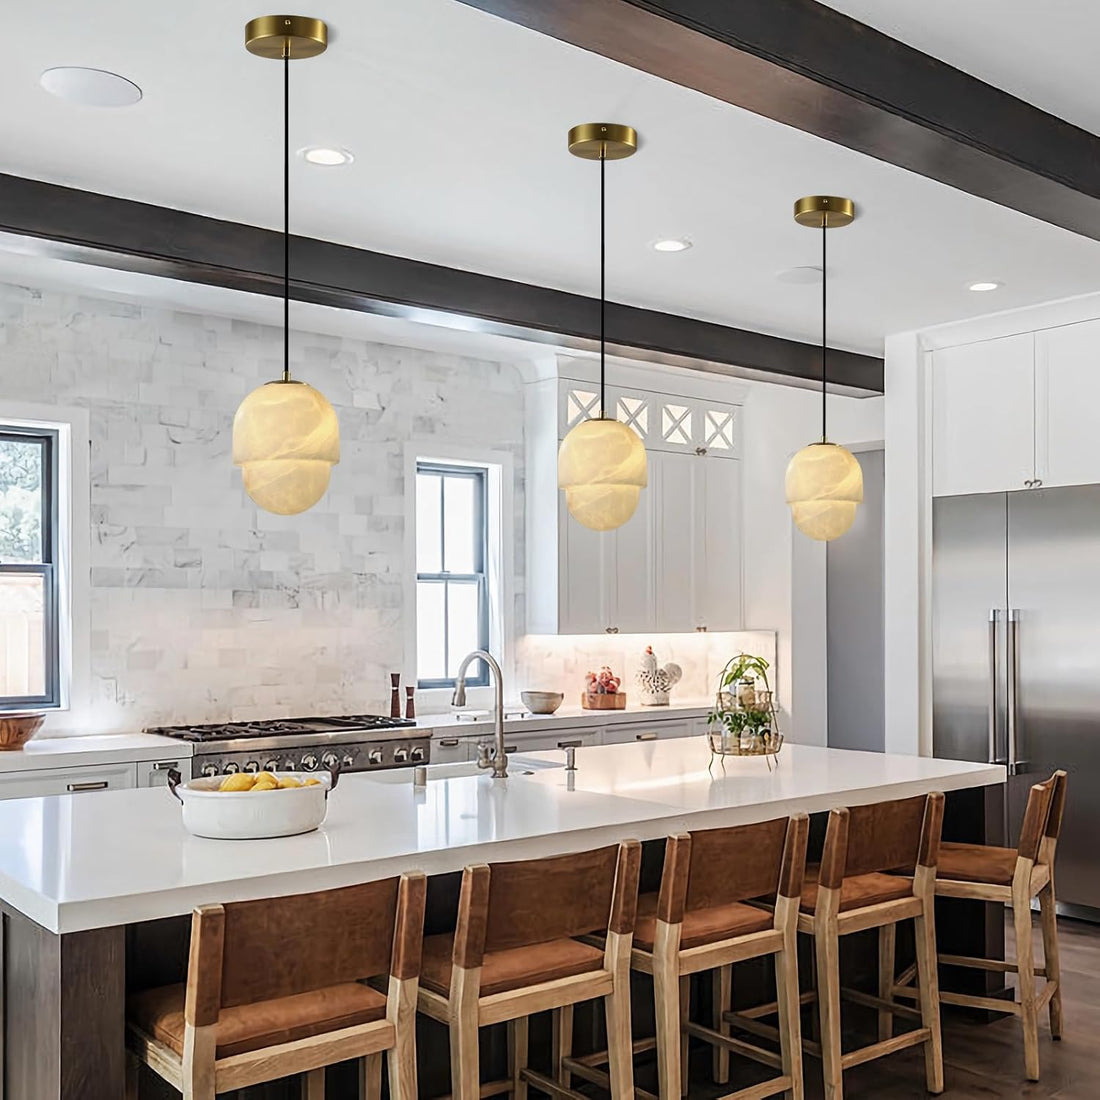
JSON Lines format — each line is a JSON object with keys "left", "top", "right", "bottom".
{"left": 127, "top": 981, "right": 386, "bottom": 1058}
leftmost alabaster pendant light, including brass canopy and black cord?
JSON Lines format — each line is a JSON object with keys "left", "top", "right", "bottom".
{"left": 233, "top": 15, "right": 340, "bottom": 516}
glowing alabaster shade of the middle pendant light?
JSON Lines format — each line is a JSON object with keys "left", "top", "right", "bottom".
{"left": 558, "top": 419, "right": 649, "bottom": 531}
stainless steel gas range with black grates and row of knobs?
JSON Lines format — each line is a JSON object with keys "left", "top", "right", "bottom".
{"left": 145, "top": 714, "right": 431, "bottom": 779}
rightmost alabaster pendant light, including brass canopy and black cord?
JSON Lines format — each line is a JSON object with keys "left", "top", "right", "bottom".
{"left": 787, "top": 195, "right": 864, "bottom": 542}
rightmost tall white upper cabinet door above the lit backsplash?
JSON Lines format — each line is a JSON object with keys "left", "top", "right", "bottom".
{"left": 695, "top": 458, "right": 741, "bottom": 630}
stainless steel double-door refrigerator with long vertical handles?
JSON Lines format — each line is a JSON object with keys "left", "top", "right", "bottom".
{"left": 932, "top": 485, "right": 1100, "bottom": 919}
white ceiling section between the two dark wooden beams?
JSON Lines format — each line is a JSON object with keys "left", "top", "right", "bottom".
{"left": 0, "top": 0, "right": 1100, "bottom": 352}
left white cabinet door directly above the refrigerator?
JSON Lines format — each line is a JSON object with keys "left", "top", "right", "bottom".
{"left": 932, "top": 333, "right": 1035, "bottom": 496}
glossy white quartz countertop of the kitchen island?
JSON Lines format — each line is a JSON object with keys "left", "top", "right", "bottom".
{"left": 0, "top": 737, "right": 1004, "bottom": 933}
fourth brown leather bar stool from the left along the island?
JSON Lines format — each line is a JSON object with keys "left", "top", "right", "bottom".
{"left": 799, "top": 793, "right": 944, "bottom": 1100}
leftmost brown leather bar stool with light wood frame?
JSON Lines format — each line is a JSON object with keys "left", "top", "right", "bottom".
{"left": 127, "top": 873, "right": 425, "bottom": 1100}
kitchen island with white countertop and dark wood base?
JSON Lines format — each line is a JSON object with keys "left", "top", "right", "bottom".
{"left": 0, "top": 738, "right": 1004, "bottom": 1100}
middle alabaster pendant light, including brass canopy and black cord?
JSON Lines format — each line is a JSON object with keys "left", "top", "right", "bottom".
{"left": 558, "top": 122, "right": 648, "bottom": 531}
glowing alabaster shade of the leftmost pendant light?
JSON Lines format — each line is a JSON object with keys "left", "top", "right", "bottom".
{"left": 233, "top": 382, "right": 340, "bottom": 516}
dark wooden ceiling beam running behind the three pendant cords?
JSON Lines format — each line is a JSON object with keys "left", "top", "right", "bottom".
{"left": 0, "top": 175, "right": 882, "bottom": 393}
